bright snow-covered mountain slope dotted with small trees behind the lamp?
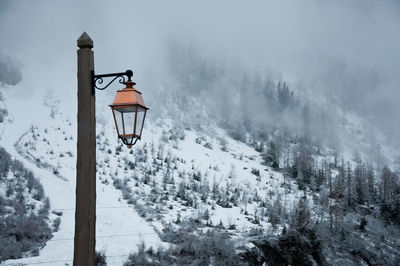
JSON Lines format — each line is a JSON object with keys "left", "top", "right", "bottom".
{"left": 0, "top": 69, "right": 396, "bottom": 265}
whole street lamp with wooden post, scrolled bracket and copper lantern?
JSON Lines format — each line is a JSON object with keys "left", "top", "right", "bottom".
{"left": 73, "top": 32, "right": 148, "bottom": 266}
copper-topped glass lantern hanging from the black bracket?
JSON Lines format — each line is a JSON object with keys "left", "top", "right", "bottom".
{"left": 109, "top": 80, "right": 149, "bottom": 148}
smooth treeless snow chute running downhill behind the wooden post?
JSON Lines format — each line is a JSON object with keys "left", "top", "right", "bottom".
{"left": 0, "top": 85, "right": 165, "bottom": 265}
